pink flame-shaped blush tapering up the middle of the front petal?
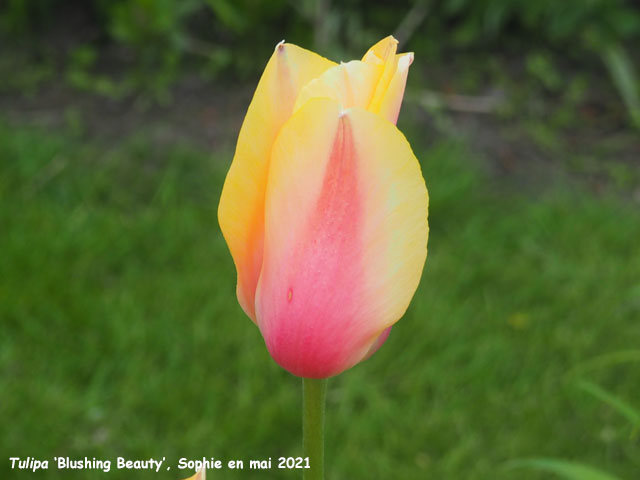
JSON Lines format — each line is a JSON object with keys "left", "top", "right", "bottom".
{"left": 260, "top": 116, "right": 371, "bottom": 378}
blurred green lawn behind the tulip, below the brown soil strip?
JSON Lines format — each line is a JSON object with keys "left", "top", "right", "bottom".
{"left": 0, "top": 119, "right": 640, "bottom": 480}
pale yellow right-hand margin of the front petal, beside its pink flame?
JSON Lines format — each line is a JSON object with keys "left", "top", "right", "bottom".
{"left": 350, "top": 103, "right": 429, "bottom": 333}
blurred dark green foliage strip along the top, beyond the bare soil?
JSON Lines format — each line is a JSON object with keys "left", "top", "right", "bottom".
{"left": 0, "top": 0, "right": 640, "bottom": 127}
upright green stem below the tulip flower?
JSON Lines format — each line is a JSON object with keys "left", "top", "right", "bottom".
{"left": 302, "top": 378, "right": 327, "bottom": 480}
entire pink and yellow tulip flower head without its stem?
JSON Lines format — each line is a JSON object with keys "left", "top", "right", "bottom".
{"left": 218, "top": 37, "right": 428, "bottom": 480}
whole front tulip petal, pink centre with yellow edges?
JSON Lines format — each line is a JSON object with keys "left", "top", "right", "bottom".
{"left": 256, "top": 99, "right": 427, "bottom": 378}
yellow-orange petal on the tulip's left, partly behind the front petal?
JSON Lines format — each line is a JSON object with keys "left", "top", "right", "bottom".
{"left": 218, "top": 43, "right": 335, "bottom": 321}
